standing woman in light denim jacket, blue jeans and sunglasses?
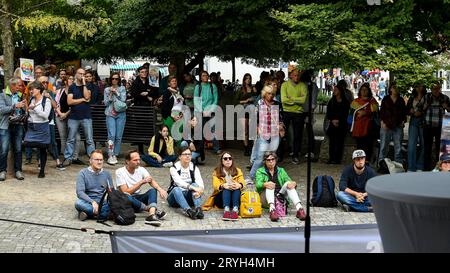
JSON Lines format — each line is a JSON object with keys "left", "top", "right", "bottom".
{"left": 103, "top": 72, "right": 127, "bottom": 165}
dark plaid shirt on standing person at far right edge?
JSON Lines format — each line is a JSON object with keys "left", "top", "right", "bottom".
{"left": 425, "top": 93, "right": 450, "bottom": 128}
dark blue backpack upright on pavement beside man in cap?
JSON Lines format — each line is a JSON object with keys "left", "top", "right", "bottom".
{"left": 311, "top": 175, "right": 337, "bottom": 207}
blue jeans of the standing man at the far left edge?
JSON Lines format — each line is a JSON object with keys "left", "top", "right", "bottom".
{"left": 0, "top": 124, "right": 24, "bottom": 172}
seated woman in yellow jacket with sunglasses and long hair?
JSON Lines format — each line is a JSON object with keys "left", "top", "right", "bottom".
{"left": 202, "top": 152, "right": 245, "bottom": 221}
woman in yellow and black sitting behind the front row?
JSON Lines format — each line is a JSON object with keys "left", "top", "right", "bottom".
{"left": 142, "top": 125, "right": 177, "bottom": 168}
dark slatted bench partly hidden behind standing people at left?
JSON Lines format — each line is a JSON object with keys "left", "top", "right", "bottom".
{"left": 55, "top": 105, "right": 157, "bottom": 152}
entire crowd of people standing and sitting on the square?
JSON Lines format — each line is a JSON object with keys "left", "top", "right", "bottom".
{"left": 0, "top": 60, "right": 450, "bottom": 226}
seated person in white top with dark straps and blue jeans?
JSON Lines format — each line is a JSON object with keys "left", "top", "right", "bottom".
{"left": 167, "top": 147, "right": 204, "bottom": 220}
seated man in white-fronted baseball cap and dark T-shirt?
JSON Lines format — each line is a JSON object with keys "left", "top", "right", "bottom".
{"left": 336, "top": 150, "right": 377, "bottom": 212}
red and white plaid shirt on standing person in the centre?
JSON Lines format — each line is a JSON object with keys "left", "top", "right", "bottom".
{"left": 258, "top": 99, "right": 282, "bottom": 140}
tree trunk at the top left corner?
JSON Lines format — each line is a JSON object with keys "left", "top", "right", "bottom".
{"left": 0, "top": 0, "right": 14, "bottom": 82}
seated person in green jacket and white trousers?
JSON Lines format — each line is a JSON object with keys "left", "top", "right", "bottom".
{"left": 256, "top": 151, "right": 306, "bottom": 222}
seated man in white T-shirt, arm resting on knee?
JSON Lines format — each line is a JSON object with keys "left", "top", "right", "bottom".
{"left": 116, "top": 150, "right": 167, "bottom": 227}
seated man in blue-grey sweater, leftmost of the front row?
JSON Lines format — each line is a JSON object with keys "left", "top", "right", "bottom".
{"left": 75, "top": 150, "right": 112, "bottom": 221}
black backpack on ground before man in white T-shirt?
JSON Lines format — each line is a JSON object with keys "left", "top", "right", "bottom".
{"left": 97, "top": 180, "right": 136, "bottom": 226}
